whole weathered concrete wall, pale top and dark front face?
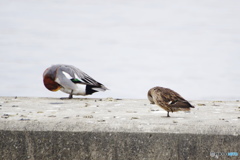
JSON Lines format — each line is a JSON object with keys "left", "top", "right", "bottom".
{"left": 0, "top": 97, "right": 240, "bottom": 160}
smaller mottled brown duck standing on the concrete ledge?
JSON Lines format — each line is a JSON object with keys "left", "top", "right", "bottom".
{"left": 147, "top": 86, "right": 195, "bottom": 117}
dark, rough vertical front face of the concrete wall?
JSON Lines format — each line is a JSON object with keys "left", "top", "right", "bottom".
{"left": 0, "top": 131, "right": 240, "bottom": 160}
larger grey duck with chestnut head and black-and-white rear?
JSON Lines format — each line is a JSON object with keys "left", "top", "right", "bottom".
{"left": 43, "top": 64, "right": 108, "bottom": 99}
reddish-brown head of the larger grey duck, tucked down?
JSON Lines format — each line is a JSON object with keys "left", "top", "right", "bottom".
{"left": 43, "top": 68, "right": 62, "bottom": 91}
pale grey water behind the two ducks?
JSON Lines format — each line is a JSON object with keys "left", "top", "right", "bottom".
{"left": 0, "top": 0, "right": 240, "bottom": 100}
